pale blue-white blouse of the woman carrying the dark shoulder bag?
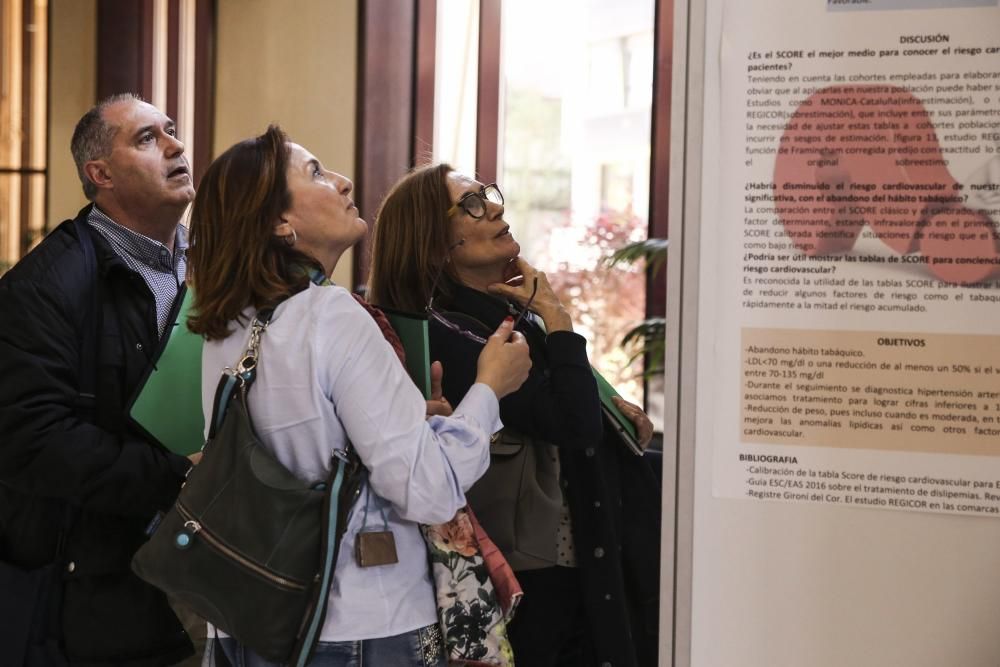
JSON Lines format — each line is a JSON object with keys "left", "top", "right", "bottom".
{"left": 202, "top": 285, "right": 502, "bottom": 641}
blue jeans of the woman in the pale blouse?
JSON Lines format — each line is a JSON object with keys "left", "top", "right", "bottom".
{"left": 202, "top": 625, "right": 448, "bottom": 667}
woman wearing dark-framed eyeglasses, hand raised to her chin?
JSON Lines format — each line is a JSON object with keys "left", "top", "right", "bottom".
{"left": 368, "top": 164, "right": 660, "bottom": 667}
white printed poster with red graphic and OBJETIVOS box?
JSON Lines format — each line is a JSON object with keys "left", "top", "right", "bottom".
{"left": 697, "top": 0, "right": 1000, "bottom": 517}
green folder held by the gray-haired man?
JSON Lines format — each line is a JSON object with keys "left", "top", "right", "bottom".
{"left": 129, "top": 289, "right": 205, "bottom": 456}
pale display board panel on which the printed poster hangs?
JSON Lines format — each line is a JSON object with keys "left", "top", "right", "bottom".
{"left": 665, "top": 0, "right": 1000, "bottom": 666}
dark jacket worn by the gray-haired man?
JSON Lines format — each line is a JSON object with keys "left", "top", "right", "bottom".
{"left": 0, "top": 207, "right": 191, "bottom": 667}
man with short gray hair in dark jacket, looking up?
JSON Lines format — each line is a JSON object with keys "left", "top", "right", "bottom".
{"left": 0, "top": 95, "right": 194, "bottom": 667}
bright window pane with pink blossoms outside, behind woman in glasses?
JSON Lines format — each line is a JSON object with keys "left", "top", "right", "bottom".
{"left": 500, "top": 0, "right": 654, "bottom": 404}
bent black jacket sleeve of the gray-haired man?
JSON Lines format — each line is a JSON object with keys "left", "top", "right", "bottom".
{"left": 0, "top": 280, "right": 190, "bottom": 516}
